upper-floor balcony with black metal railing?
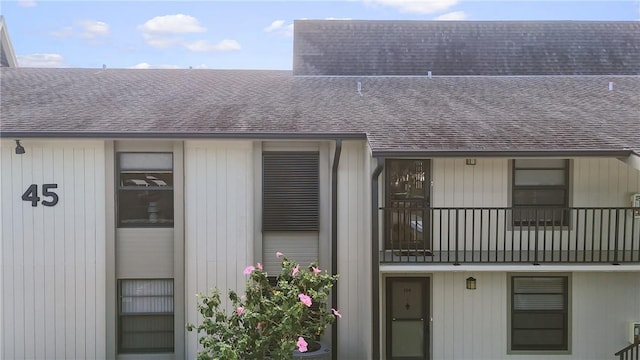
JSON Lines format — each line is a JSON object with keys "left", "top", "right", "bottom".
{"left": 380, "top": 204, "right": 640, "bottom": 265}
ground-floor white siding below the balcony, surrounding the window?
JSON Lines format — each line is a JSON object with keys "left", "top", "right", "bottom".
{"left": 424, "top": 272, "right": 640, "bottom": 360}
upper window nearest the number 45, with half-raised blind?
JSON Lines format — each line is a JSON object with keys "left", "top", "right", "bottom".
{"left": 118, "top": 153, "right": 173, "bottom": 227}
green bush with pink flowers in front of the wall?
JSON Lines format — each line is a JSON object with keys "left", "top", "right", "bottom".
{"left": 187, "top": 252, "right": 342, "bottom": 360}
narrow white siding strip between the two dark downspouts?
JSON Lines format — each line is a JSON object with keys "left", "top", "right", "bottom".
{"left": 337, "top": 141, "right": 373, "bottom": 359}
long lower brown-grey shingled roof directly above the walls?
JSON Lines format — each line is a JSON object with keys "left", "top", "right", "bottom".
{"left": 0, "top": 68, "right": 640, "bottom": 155}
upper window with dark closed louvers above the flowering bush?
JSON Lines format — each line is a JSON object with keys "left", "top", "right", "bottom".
{"left": 262, "top": 152, "right": 320, "bottom": 231}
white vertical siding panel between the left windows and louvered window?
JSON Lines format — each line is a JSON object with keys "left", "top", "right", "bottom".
{"left": 185, "top": 141, "right": 254, "bottom": 359}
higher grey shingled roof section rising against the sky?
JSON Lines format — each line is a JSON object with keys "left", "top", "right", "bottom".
{"left": 293, "top": 20, "right": 640, "bottom": 76}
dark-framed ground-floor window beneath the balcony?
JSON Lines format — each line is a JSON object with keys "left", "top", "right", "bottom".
{"left": 510, "top": 276, "right": 569, "bottom": 351}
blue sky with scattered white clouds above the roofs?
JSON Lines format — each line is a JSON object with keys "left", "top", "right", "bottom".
{"left": 0, "top": 0, "right": 640, "bottom": 70}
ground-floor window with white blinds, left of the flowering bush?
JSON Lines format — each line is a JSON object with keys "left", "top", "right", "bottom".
{"left": 118, "top": 279, "right": 174, "bottom": 354}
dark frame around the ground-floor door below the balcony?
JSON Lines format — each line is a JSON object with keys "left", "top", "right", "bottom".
{"left": 383, "top": 275, "right": 432, "bottom": 360}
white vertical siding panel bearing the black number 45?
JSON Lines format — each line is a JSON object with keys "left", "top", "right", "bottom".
{"left": 0, "top": 139, "right": 105, "bottom": 359}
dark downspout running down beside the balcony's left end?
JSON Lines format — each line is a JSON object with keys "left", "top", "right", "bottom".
{"left": 371, "top": 157, "right": 384, "bottom": 360}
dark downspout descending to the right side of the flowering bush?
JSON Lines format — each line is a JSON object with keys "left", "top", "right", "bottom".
{"left": 331, "top": 139, "right": 342, "bottom": 360}
